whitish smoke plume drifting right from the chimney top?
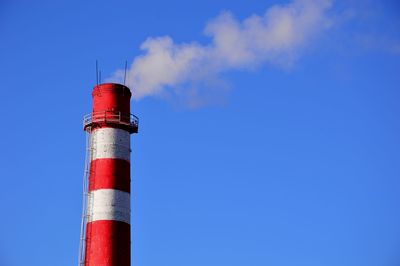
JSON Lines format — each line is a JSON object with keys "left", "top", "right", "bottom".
{"left": 110, "top": 0, "right": 332, "bottom": 102}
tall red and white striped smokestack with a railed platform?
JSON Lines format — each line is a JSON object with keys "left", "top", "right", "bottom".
{"left": 79, "top": 83, "right": 138, "bottom": 266}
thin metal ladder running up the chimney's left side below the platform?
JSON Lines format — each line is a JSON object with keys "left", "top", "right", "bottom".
{"left": 78, "top": 128, "right": 92, "bottom": 266}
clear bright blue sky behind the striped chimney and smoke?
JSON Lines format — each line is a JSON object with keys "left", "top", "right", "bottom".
{"left": 0, "top": 0, "right": 400, "bottom": 266}
